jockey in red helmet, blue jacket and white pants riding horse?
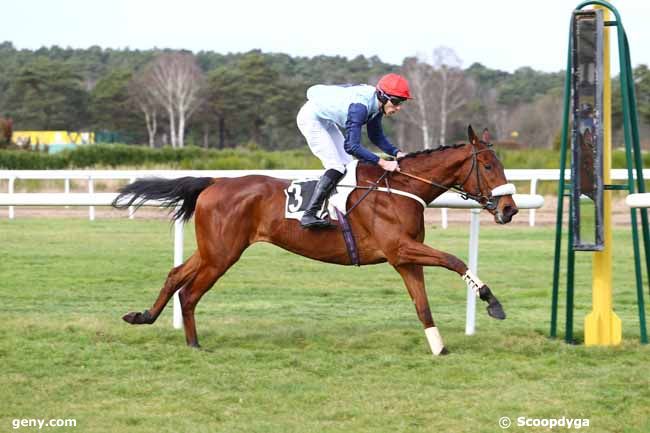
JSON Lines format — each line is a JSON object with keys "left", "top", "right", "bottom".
{"left": 296, "top": 74, "right": 411, "bottom": 228}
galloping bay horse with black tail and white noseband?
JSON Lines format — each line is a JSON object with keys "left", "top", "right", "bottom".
{"left": 113, "top": 126, "right": 518, "bottom": 355}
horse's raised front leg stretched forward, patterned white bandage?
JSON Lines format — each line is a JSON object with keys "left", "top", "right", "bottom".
{"left": 389, "top": 239, "right": 506, "bottom": 320}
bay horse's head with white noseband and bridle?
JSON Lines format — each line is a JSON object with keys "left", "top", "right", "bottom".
{"left": 460, "top": 125, "right": 519, "bottom": 224}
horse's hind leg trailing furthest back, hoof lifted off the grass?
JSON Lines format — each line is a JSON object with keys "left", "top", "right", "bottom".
{"left": 122, "top": 252, "right": 200, "bottom": 325}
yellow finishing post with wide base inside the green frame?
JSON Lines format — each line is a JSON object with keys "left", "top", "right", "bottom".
{"left": 585, "top": 6, "right": 623, "bottom": 346}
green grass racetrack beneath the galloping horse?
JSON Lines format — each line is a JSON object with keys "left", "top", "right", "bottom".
{"left": 0, "top": 219, "right": 650, "bottom": 433}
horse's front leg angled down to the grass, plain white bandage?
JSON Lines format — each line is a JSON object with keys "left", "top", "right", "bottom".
{"left": 395, "top": 264, "right": 449, "bottom": 356}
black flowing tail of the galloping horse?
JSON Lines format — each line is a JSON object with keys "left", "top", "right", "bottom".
{"left": 112, "top": 177, "right": 214, "bottom": 222}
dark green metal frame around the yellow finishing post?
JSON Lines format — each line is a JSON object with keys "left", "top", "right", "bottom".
{"left": 550, "top": 0, "right": 650, "bottom": 344}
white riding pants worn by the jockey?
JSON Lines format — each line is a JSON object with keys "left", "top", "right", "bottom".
{"left": 296, "top": 101, "right": 353, "bottom": 173}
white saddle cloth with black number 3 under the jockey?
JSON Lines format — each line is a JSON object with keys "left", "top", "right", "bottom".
{"left": 284, "top": 160, "right": 359, "bottom": 220}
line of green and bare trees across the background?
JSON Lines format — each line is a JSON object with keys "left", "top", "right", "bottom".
{"left": 0, "top": 42, "right": 650, "bottom": 151}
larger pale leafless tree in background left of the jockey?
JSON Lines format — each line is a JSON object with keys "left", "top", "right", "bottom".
{"left": 144, "top": 53, "right": 204, "bottom": 147}
